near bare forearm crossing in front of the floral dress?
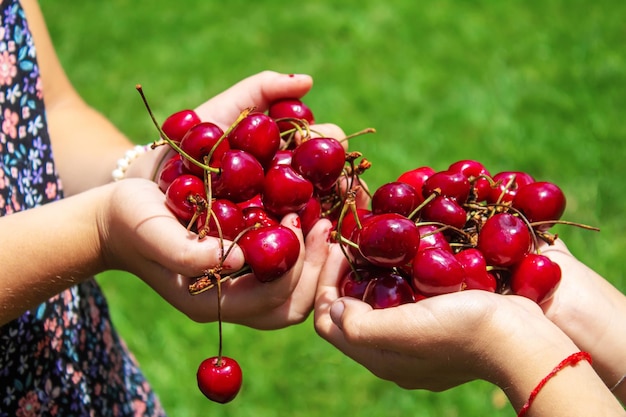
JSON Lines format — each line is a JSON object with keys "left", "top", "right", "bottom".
{"left": 0, "top": 187, "right": 108, "bottom": 324}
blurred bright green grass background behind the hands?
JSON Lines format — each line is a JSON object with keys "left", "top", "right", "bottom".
{"left": 41, "top": 0, "right": 626, "bottom": 417}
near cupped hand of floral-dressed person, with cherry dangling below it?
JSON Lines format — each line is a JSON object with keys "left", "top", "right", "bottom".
{"left": 98, "top": 179, "right": 331, "bottom": 329}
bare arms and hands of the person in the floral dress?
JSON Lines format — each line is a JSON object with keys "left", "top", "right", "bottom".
{"left": 0, "top": 0, "right": 344, "bottom": 329}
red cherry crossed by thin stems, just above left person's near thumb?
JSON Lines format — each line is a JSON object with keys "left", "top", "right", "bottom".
{"left": 197, "top": 199, "right": 246, "bottom": 240}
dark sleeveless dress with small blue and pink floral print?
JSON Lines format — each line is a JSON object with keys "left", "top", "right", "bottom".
{"left": 0, "top": 0, "right": 164, "bottom": 417}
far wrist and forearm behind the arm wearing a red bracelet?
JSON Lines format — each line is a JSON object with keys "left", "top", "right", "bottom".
{"left": 540, "top": 239, "right": 626, "bottom": 390}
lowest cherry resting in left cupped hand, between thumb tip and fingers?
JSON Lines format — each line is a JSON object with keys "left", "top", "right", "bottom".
{"left": 238, "top": 224, "right": 300, "bottom": 282}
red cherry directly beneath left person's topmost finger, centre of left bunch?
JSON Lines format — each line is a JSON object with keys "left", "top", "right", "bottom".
{"left": 228, "top": 112, "right": 280, "bottom": 168}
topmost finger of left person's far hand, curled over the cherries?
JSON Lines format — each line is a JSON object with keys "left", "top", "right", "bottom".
{"left": 196, "top": 71, "right": 313, "bottom": 127}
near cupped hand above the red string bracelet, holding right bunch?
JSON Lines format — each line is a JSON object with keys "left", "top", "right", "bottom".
{"left": 315, "top": 245, "right": 572, "bottom": 391}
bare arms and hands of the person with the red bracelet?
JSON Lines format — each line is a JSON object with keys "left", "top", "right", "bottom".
{"left": 315, "top": 243, "right": 626, "bottom": 417}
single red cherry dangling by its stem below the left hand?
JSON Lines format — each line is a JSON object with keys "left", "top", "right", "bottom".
{"left": 196, "top": 356, "right": 243, "bottom": 404}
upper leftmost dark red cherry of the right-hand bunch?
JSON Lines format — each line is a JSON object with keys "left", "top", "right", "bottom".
{"left": 371, "top": 181, "right": 423, "bottom": 217}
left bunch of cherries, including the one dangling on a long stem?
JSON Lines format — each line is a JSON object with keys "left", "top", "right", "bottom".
{"left": 137, "top": 86, "right": 368, "bottom": 403}
